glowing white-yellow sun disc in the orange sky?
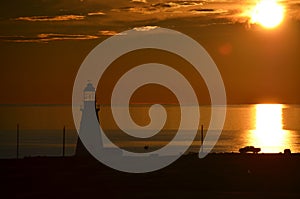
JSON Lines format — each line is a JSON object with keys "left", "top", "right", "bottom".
{"left": 250, "top": 0, "right": 284, "bottom": 29}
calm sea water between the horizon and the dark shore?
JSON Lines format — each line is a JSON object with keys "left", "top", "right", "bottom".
{"left": 0, "top": 104, "right": 300, "bottom": 158}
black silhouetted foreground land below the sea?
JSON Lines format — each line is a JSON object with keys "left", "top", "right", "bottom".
{"left": 0, "top": 154, "right": 300, "bottom": 199}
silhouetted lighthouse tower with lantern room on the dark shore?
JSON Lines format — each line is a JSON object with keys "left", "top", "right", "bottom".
{"left": 75, "top": 82, "right": 103, "bottom": 157}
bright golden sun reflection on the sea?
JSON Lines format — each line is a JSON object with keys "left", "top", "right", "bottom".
{"left": 248, "top": 104, "right": 291, "bottom": 153}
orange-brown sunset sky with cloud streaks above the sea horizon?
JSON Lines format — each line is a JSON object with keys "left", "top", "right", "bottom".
{"left": 0, "top": 0, "right": 300, "bottom": 104}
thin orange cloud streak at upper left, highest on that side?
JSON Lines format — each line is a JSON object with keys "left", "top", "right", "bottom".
{"left": 15, "top": 15, "right": 85, "bottom": 21}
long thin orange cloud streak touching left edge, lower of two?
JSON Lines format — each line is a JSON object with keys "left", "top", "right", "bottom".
{"left": 0, "top": 33, "right": 99, "bottom": 43}
